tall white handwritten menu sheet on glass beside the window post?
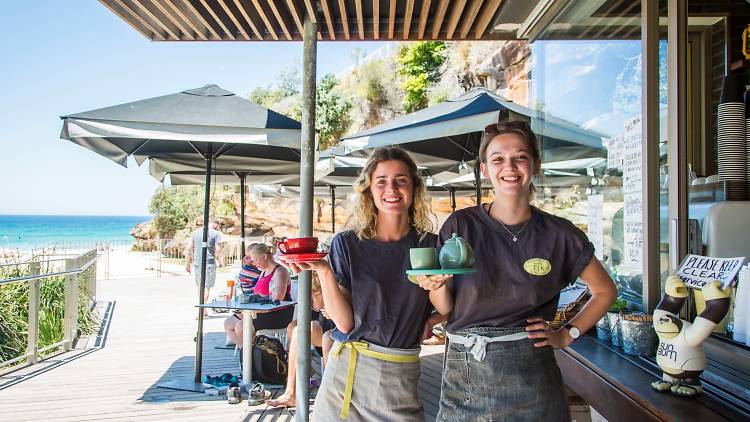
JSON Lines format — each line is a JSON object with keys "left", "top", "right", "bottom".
{"left": 622, "top": 116, "right": 643, "bottom": 270}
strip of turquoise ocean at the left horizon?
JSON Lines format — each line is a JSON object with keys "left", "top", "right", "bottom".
{"left": 0, "top": 215, "right": 151, "bottom": 249}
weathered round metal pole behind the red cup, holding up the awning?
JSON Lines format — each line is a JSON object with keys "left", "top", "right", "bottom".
{"left": 295, "top": 16, "right": 318, "bottom": 422}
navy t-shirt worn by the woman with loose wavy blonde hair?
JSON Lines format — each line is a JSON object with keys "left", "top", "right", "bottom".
{"left": 328, "top": 230, "right": 437, "bottom": 349}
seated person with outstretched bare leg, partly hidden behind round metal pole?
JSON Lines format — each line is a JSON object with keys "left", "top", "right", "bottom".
{"left": 266, "top": 273, "right": 334, "bottom": 407}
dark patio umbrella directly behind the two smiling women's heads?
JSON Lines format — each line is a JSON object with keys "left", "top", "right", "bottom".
{"left": 341, "top": 88, "right": 604, "bottom": 203}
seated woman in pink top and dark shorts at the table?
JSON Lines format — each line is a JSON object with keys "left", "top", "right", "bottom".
{"left": 224, "top": 243, "right": 294, "bottom": 345}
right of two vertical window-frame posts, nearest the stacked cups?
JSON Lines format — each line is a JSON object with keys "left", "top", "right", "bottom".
{"left": 667, "top": 0, "right": 688, "bottom": 272}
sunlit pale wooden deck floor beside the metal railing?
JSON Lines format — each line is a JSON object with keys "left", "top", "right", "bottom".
{"left": 0, "top": 276, "right": 442, "bottom": 422}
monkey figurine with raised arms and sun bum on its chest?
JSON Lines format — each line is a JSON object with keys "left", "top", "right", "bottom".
{"left": 651, "top": 275, "right": 729, "bottom": 397}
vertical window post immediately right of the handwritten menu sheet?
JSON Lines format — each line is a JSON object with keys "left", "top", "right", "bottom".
{"left": 641, "top": 0, "right": 661, "bottom": 313}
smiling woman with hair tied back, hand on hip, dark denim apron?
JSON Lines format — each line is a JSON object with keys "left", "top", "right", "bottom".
{"left": 437, "top": 121, "right": 617, "bottom": 421}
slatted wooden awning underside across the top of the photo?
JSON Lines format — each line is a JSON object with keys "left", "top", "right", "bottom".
{"left": 100, "top": 0, "right": 520, "bottom": 41}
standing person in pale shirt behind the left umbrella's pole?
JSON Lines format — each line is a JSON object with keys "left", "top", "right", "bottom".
{"left": 185, "top": 218, "right": 224, "bottom": 315}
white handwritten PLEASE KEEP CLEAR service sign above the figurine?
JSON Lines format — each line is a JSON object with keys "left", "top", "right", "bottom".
{"left": 677, "top": 255, "right": 745, "bottom": 290}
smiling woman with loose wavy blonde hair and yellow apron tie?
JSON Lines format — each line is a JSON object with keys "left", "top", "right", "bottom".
{"left": 291, "top": 147, "right": 453, "bottom": 422}
